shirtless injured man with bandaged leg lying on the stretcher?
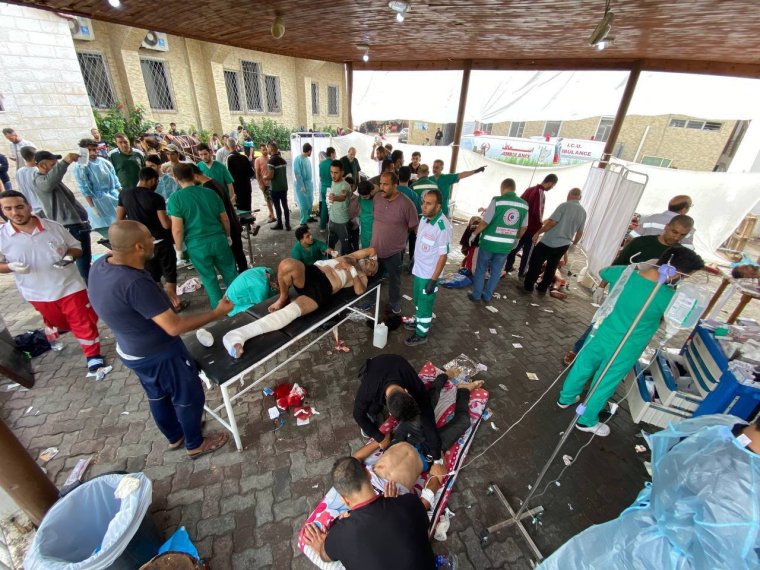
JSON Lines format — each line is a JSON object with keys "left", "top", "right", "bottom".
{"left": 223, "top": 247, "right": 378, "bottom": 358}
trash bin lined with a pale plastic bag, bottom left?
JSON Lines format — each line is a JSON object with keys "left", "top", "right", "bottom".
{"left": 24, "top": 473, "right": 163, "bottom": 570}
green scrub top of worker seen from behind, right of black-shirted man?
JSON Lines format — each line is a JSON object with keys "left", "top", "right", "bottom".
{"left": 166, "top": 186, "right": 225, "bottom": 243}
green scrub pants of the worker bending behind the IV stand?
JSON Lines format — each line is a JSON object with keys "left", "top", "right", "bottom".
{"left": 559, "top": 337, "right": 646, "bottom": 427}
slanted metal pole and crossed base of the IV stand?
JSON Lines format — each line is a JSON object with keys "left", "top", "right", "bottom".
{"left": 481, "top": 280, "right": 662, "bottom": 561}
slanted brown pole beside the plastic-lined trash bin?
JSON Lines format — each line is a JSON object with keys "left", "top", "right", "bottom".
{"left": 0, "top": 420, "right": 60, "bottom": 526}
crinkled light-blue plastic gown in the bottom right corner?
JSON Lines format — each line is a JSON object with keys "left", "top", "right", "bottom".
{"left": 539, "top": 415, "right": 760, "bottom": 570}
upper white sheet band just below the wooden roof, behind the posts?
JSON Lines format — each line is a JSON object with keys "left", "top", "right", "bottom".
{"left": 352, "top": 71, "right": 760, "bottom": 125}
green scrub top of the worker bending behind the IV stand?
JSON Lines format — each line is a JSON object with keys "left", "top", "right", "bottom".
{"left": 594, "top": 265, "right": 674, "bottom": 348}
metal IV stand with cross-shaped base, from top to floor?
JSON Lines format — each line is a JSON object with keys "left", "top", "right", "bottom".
{"left": 480, "top": 264, "right": 675, "bottom": 562}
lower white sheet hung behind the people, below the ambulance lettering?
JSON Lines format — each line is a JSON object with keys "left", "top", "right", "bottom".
{"left": 332, "top": 132, "right": 760, "bottom": 257}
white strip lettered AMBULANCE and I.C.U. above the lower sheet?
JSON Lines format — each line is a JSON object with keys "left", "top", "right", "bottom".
{"left": 462, "top": 135, "right": 604, "bottom": 166}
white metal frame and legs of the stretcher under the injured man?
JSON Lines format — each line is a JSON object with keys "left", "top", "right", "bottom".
{"left": 199, "top": 281, "right": 382, "bottom": 451}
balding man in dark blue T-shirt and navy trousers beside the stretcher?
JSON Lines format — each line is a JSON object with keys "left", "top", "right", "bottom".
{"left": 88, "top": 220, "right": 232, "bottom": 459}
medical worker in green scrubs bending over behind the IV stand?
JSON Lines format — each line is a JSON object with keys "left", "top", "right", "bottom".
{"left": 557, "top": 246, "right": 704, "bottom": 437}
